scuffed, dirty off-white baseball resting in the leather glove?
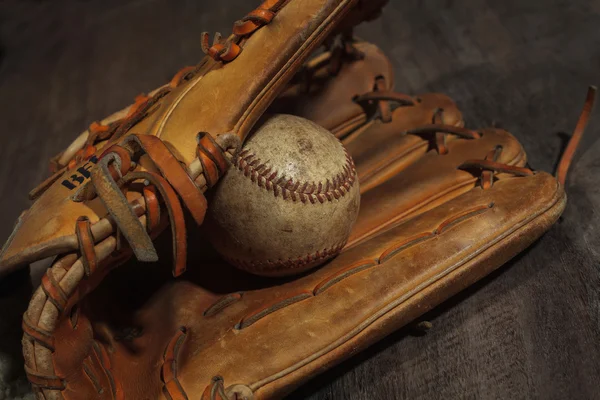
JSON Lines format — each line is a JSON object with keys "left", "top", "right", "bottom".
{"left": 206, "top": 114, "right": 360, "bottom": 276}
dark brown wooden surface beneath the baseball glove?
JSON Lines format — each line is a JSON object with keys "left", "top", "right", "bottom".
{"left": 0, "top": 0, "right": 600, "bottom": 400}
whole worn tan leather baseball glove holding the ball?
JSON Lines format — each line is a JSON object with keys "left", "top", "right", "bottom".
{"left": 0, "top": 0, "right": 591, "bottom": 399}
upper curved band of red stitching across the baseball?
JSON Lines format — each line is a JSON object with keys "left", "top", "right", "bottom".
{"left": 233, "top": 148, "right": 356, "bottom": 204}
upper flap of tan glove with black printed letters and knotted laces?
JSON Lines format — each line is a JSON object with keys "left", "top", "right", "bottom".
{"left": 0, "top": 0, "right": 392, "bottom": 273}
